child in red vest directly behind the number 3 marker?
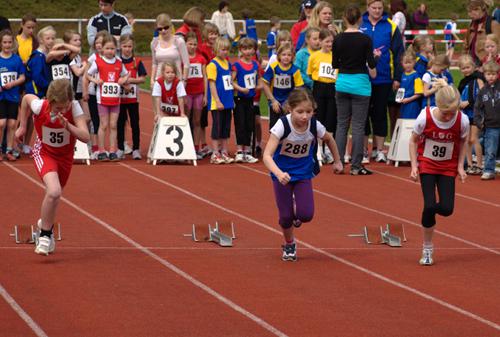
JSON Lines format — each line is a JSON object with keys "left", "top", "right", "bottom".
{"left": 151, "top": 62, "right": 186, "bottom": 118}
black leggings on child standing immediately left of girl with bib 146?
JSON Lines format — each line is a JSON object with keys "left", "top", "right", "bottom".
{"left": 234, "top": 97, "right": 255, "bottom": 146}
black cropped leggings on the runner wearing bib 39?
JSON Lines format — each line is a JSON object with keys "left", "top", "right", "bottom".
{"left": 420, "top": 173, "right": 455, "bottom": 228}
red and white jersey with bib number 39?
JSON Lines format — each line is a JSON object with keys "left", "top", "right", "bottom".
{"left": 414, "top": 107, "right": 469, "bottom": 177}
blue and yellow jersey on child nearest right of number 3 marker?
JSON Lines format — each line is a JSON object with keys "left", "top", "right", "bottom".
{"left": 207, "top": 57, "right": 234, "bottom": 110}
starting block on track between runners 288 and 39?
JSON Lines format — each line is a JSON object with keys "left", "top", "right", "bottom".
{"left": 348, "top": 224, "right": 406, "bottom": 247}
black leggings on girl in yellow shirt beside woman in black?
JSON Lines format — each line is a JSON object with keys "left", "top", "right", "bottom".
{"left": 313, "top": 81, "right": 337, "bottom": 133}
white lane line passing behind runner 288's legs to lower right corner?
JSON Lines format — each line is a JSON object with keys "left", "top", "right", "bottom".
{"left": 119, "top": 163, "right": 500, "bottom": 331}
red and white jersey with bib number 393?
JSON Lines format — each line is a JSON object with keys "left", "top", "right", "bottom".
{"left": 88, "top": 56, "right": 127, "bottom": 106}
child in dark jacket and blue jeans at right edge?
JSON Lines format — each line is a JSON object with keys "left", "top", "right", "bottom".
{"left": 474, "top": 61, "right": 500, "bottom": 180}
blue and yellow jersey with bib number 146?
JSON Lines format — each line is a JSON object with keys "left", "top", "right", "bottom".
{"left": 262, "top": 62, "right": 304, "bottom": 104}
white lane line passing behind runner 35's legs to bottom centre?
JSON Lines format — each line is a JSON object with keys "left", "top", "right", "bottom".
{"left": 4, "top": 162, "right": 287, "bottom": 337}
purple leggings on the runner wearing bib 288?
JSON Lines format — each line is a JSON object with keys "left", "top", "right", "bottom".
{"left": 273, "top": 179, "right": 314, "bottom": 228}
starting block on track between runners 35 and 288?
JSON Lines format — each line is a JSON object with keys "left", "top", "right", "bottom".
{"left": 184, "top": 220, "right": 236, "bottom": 247}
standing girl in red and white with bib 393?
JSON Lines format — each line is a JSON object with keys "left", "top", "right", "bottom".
{"left": 87, "top": 34, "right": 128, "bottom": 161}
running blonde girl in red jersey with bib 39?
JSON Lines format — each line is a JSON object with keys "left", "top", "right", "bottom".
{"left": 410, "top": 85, "right": 469, "bottom": 266}
